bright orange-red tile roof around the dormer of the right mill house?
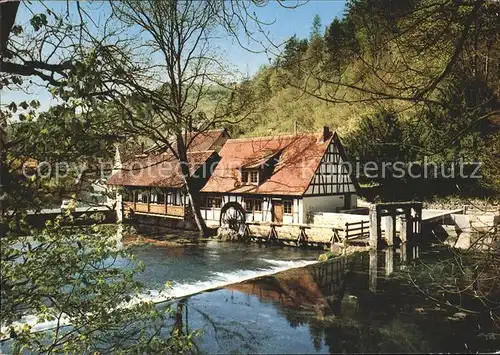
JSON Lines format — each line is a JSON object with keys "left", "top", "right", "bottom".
{"left": 201, "top": 133, "right": 334, "bottom": 195}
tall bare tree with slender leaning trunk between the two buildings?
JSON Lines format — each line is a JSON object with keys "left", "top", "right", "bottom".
{"left": 93, "top": 1, "right": 264, "bottom": 235}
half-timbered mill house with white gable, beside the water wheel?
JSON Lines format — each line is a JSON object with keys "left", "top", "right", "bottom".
{"left": 201, "top": 127, "right": 358, "bottom": 224}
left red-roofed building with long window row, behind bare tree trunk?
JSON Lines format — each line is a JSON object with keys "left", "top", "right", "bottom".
{"left": 108, "top": 129, "right": 229, "bottom": 220}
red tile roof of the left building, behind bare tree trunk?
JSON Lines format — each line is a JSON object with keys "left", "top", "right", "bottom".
{"left": 108, "top": 129, "right": 225, "bottom": 187}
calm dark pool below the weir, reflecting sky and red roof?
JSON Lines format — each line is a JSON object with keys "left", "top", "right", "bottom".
{"left": 176, "top": 248, "right": 500, "bottom": 353}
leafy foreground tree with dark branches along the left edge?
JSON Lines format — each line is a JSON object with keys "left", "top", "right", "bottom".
{"left": 0, "top": 3, "right": 192, "bottom": 353}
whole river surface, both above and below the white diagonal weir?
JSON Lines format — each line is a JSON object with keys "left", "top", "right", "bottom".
{"left": 124, "top": 242, "right": 500, "bottom": 354}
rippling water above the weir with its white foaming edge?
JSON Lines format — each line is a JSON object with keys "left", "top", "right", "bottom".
{"left": 123, "top": 242, "right": 321, "bottom": 301}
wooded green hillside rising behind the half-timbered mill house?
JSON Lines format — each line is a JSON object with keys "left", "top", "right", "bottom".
{"left": 229, "top": 0, "right": 500, "bottom": 194}
